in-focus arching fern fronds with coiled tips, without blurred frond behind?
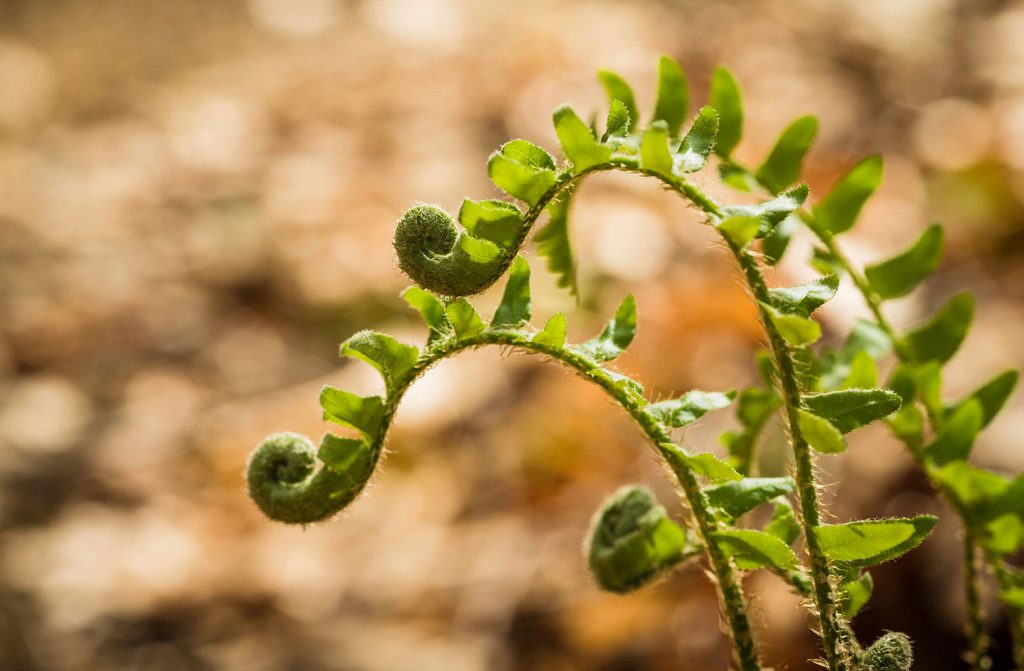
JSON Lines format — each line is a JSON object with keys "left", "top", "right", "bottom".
{"left": 241, "top": 57, "right": 950, "bottom": 671}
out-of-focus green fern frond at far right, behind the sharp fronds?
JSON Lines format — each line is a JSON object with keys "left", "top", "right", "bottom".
{"left": 713, "top": 70, "right": 1024, "bottom": 671}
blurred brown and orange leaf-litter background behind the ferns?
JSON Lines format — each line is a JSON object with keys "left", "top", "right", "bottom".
{"left": 0, "top": 0, "right": 1024, "bottom": 671}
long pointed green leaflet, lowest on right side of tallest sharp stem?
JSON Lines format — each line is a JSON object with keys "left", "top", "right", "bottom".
{"left": 813, "top": 515, "right": 939, "bottom": 567}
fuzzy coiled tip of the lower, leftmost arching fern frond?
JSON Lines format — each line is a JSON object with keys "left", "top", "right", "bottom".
{"left": 246, "top": 433, "right": 376, "bottom": 525}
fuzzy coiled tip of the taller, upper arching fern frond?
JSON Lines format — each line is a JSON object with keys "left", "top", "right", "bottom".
{"left": 394, "top": 205, "right": 521, "bottom": 296}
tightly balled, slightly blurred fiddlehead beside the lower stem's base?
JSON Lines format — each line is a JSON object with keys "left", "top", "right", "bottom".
{"left": 587, "top": 485, "right": 699, "bottom": 593}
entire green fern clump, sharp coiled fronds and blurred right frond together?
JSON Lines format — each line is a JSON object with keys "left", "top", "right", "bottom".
{"left": 248, "top": 57, "right": 1024, "bottom": 671}
